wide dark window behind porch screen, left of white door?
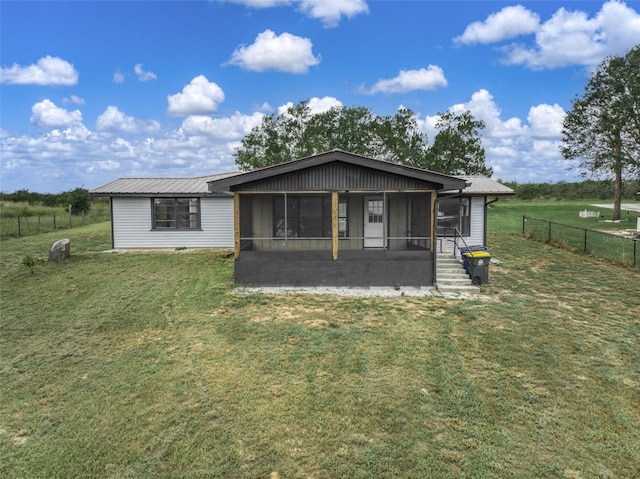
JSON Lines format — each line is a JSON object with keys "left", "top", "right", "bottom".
{"left": 273, "top": 196, "right": 347, "bottom": 238}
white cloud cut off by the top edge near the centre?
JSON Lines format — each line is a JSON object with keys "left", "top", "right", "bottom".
{"left": 221, "top": 0, "right": 369, "bottom": 28}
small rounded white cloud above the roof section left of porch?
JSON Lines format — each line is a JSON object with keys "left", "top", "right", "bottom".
{"left": 167, "top": 75, "right": 224, "bottom": 116}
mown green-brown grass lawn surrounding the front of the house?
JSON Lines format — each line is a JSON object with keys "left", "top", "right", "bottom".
{"left": 0, "top": 212, "right": 640, "bottom": 479}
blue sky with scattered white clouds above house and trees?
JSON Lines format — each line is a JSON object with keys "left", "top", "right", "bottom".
{"left": 0, "top": 0, "right": 640, "bottom": 193}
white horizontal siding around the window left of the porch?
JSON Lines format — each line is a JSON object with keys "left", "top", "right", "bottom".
{"left": 112, "top": 197, "right": 233, "bottom": 248}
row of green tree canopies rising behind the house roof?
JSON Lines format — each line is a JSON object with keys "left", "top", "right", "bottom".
{"left": 235, "top": 101, "right": 491, "bottom": 175}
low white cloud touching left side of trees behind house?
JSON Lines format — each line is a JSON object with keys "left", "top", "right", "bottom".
{"left": 182, "top": 112, "right": 264, "bottom": 140}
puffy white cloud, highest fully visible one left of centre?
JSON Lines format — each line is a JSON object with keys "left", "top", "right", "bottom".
{"left": 228, "top": 30, "right": 320, "bottom": 74}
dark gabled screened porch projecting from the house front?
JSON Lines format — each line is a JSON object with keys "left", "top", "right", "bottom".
{"left": 209, "top": 151, "right": 465, "bottom": 286}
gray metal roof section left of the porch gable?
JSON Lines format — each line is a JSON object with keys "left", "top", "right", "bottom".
{"left": 89, "top": 171, "right": 241, "bottom": 196}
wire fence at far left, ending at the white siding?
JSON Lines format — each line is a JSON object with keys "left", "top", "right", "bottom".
{"left": 0, "top": 209, "right": 110, "bottom": 238}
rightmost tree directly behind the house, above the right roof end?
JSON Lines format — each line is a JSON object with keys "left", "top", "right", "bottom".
{"left": 424, "top": 110, "right": 493, "bottom": 176}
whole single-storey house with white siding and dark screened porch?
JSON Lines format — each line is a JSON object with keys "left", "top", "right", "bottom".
{"left": 91, "top": 150, "right": 513, "bottom": 286}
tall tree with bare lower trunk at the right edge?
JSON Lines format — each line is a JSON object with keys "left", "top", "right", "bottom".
{"left": 560, "top": 45, "right": 640, "bottom": 219}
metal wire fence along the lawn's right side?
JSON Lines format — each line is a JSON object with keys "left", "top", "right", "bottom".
{"left": 522, "top": 216, "right": 640, "bottom": 267}
